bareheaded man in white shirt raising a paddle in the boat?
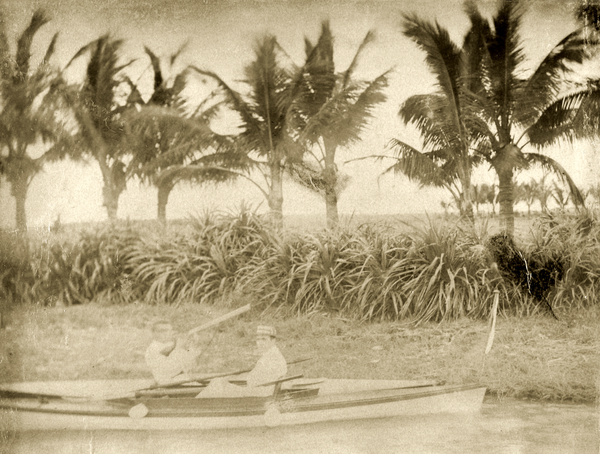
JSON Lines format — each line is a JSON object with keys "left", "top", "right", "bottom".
{"left": 145, "top": 320, "right": 201, "bottom": 383}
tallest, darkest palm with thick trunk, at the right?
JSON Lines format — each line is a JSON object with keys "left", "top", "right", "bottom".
{"left": 467, "top": 0, "right": 586, "bottom": 234}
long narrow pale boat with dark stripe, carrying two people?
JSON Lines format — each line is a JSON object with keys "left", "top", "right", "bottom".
{"left": 0, "top": 379, "right": 486, "bottom": 431}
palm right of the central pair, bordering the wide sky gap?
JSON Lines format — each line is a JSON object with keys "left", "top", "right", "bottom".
{"left": 290, "top": 21, "right": 388, "bottom": 228}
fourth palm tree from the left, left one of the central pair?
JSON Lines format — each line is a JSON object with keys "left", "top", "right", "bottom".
{"left": 192, "top": 35, "right": 302, "bottom": 228}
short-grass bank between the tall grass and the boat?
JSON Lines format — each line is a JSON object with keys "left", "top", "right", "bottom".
{"left": 0, "top": 304, "right": 600, "bottom": 402}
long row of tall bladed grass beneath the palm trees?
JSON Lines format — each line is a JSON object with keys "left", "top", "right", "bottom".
{"left": 0, "top": 209, "right": 600, "bottom": 323}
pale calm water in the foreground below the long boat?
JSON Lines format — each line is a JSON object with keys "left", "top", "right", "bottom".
{"left": 2, "top": 399, "right": 600, "bottom": 454}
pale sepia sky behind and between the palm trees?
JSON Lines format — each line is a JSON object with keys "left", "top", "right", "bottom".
{"left": 0, "top": 0, "right": 599, "bottom": 227}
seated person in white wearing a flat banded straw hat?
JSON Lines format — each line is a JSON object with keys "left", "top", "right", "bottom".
{"left": 196, "top": 325, "right": 287, "bottom": 397}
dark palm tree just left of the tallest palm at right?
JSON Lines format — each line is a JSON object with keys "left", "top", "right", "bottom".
{"left": 368, "top": 8, "right": 489, "bottom": 220}
